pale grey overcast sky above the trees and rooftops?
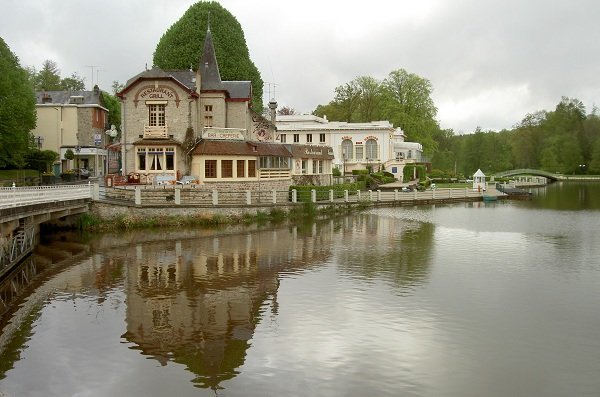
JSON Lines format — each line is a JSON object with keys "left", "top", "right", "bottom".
{"left": 0, "top": 0, "right": 600, "bottom": 133}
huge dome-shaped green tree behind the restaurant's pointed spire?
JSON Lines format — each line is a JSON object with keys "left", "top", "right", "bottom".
{"left": 153, "top": 1, "right": 263, "bottom": 113}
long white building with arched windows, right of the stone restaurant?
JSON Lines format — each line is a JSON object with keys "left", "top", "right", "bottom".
{"left": 276, "top": 115, "right": 423, "bottom": 180}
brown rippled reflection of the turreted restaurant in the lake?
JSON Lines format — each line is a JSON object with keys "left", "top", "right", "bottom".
{"left": 123, "top": 222, "right": 334, "bottom": 389}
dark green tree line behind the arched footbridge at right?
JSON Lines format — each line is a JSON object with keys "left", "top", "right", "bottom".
{"left": 432, "top": 97, "right": 600, "bottom": 175}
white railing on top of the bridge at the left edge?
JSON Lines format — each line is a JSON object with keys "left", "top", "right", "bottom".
{"left": 0, "top": 183, "right": 93, "bottom": 208}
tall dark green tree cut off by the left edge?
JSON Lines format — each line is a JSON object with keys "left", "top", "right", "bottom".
{"left": 0, "top": 38, "right": 36, "bottom": 168}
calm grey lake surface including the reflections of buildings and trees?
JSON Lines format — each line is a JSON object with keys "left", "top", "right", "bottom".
{"left": 0, "top": 184, "right": 600, "bottom": 396}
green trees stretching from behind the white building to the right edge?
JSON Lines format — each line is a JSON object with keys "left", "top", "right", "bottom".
{"left": 313, "top": 69, "right": 600, "bottom": 177}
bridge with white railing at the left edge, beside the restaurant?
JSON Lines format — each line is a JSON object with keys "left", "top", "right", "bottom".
{"left": 0, "top": 184, "right": 94, "bottom": 279}
